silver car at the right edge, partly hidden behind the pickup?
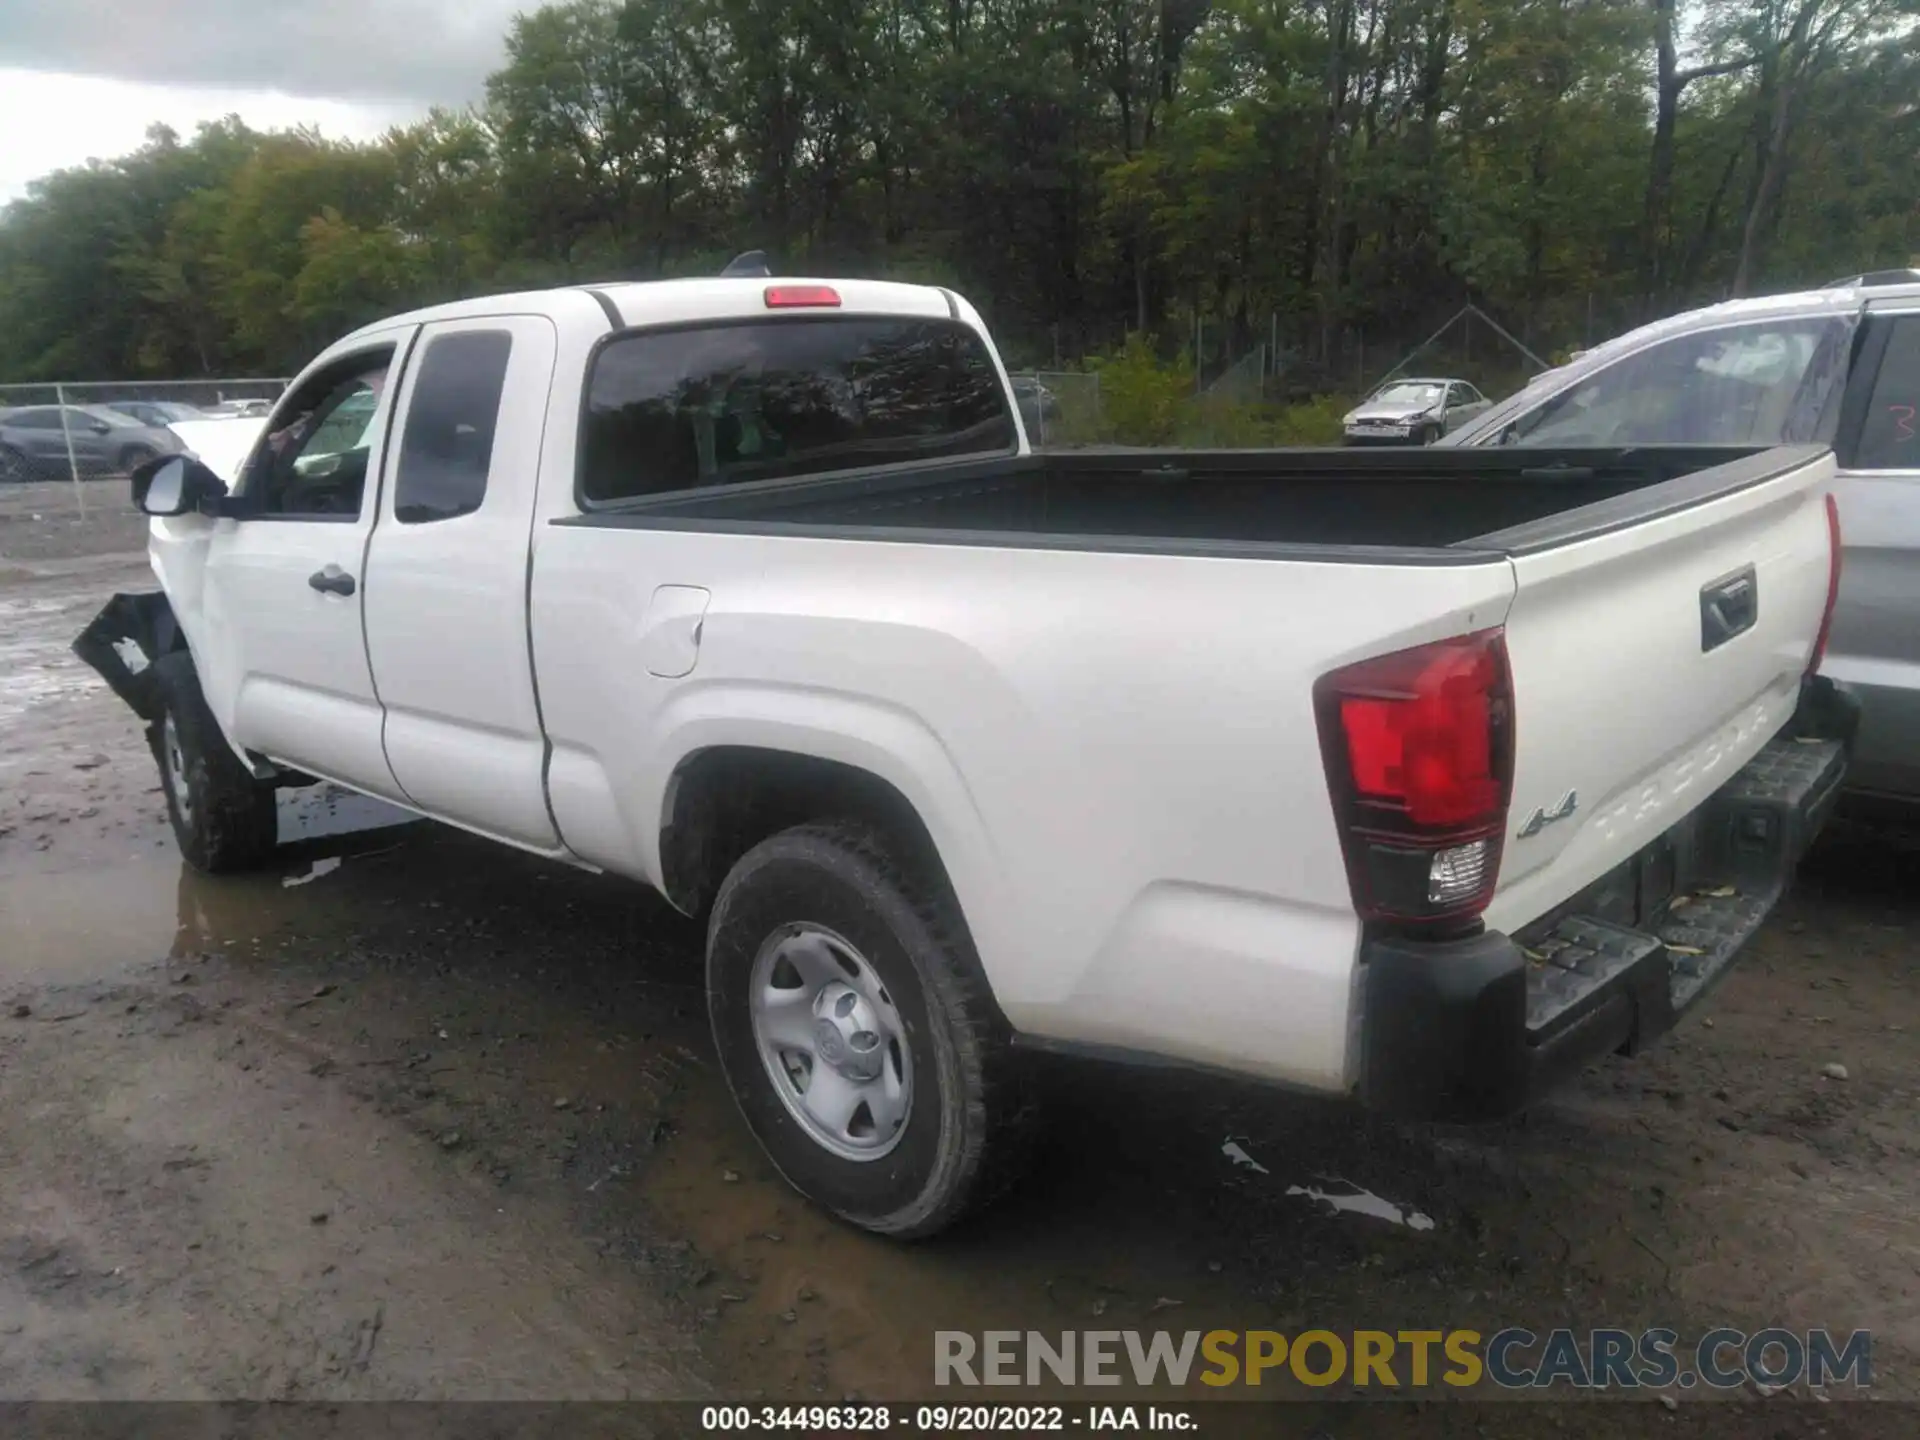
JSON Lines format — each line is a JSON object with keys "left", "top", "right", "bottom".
{"left": 1446, "top": 271, "right": 1920, "bottom": 804}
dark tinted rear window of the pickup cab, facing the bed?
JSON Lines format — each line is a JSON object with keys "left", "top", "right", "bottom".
{"left": 580, "top": 317, "right": 1014, "bottom": 505}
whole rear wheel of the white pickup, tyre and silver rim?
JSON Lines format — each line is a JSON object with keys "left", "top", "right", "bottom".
{"left": 707, "top": 824, "right": 1031, "bottom": 1238}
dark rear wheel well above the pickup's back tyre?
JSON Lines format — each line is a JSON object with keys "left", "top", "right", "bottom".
{"left": 660, "top": 745, "right": 958, "bottom": 916}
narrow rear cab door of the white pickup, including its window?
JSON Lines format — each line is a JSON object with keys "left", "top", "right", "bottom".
{"left": 367, "top": 315, "right": 561, "bottom": 852}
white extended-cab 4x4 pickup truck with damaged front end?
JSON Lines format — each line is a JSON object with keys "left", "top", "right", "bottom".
{"left": 75, "top": 276, "right": 1855, "bottom": 1236}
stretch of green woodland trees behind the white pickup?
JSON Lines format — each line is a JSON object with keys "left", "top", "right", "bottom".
{"left": 0, "top": 0, "right": 1920, "bottom": 389}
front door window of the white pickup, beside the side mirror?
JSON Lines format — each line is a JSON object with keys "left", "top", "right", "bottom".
{"left": 238, "top": 348, "right": 394, "bottom": 520}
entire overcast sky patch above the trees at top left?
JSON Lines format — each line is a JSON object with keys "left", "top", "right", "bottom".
{"left": 0, "top": 0, "right": 538, "bottom": 204}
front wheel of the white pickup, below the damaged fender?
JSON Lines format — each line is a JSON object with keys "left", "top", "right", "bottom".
{"left": 148, "top": 651, "right": 278, "bottom": 876}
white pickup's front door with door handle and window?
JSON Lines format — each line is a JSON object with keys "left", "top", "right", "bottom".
{"left": 168, "top": 326, "right": 415, "bottom": 799}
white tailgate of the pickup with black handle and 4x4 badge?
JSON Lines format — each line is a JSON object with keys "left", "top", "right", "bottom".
{"left": 1476, "top": 449, "right": 1834, "bottom": 931}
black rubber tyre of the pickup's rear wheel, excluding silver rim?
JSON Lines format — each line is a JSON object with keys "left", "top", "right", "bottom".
{"left": 707, "top": 822, "right": 1033, "bottom": 1238}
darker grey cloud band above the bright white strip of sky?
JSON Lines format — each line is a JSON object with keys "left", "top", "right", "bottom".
{"left": 0, "top": 0, "right": 532, "bottom": 106}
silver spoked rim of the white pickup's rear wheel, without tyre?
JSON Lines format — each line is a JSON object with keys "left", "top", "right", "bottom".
{"left": 751, "top": 925, "right": 914, "bottom": 1160}
